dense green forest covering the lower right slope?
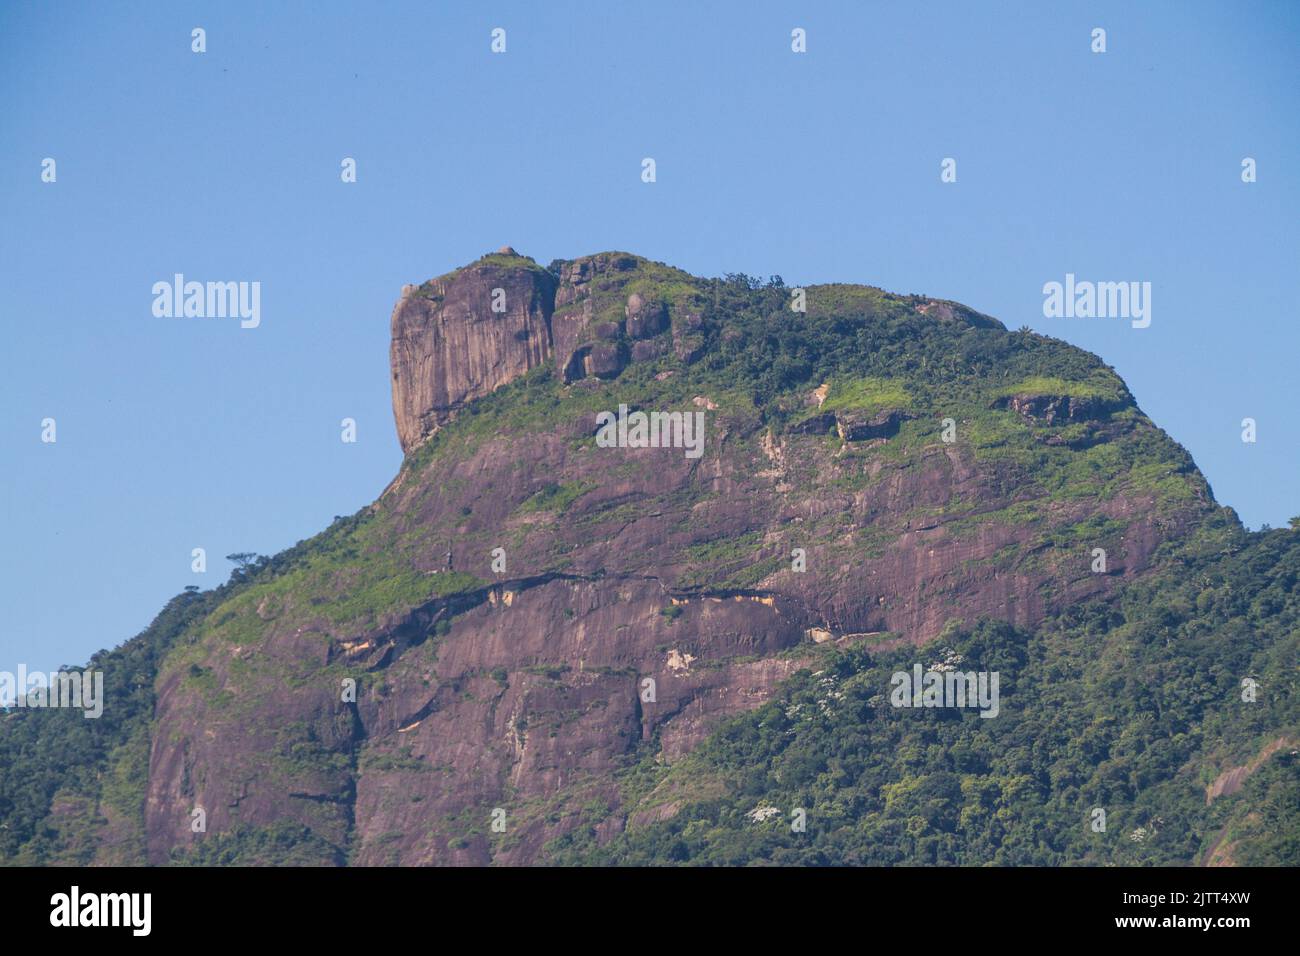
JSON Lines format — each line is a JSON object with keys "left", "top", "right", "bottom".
{"left": 547, "top": 520, "right": 1300, "bottom": 866}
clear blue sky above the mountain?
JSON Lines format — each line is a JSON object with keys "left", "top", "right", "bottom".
{"left": 0, "top": 1, "right": 1300, "bottom": 670}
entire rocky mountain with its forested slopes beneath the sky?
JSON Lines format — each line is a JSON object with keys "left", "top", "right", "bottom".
{"left": 0, "top": 247, "right": 1300, "bottom": 865}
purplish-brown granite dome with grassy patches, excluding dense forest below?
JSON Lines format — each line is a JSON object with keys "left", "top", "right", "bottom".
{"left": 129, "top": 250, "right": 1214, "bottom": 865}
